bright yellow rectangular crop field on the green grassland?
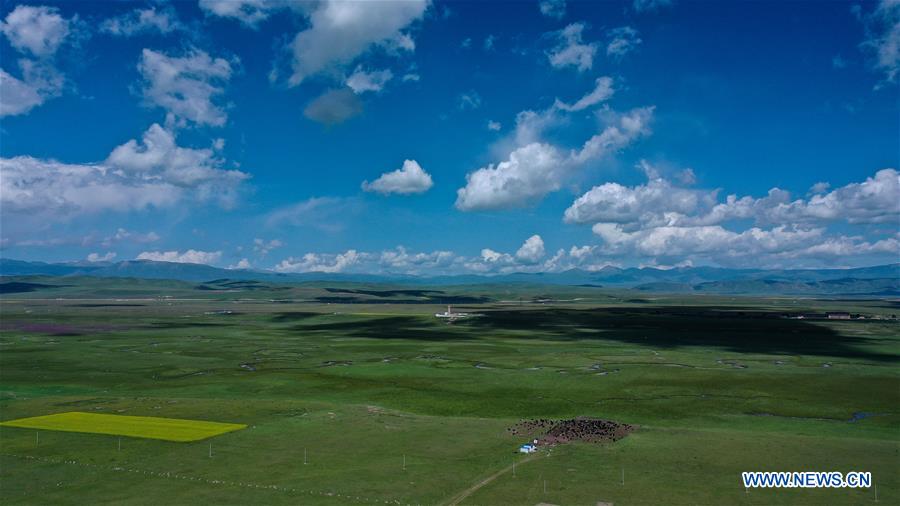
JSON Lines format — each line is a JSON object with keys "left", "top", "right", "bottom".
{"left": 0, "top": 411, "right": 247, "bottom": 442}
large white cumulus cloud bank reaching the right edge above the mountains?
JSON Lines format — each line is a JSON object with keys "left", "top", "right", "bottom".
{"left": 564, "top": 161, "right": 900, "bottom": 266}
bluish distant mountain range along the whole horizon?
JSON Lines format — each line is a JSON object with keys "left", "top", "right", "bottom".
{"left": 0, "top": 259, "right": 900, "bottom": 296}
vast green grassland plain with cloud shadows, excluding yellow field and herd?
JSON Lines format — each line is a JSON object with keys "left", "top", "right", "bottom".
{"left": 0, "top": 278, "right": 900, "bottom": 505}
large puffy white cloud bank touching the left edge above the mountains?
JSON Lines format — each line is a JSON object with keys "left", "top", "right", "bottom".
{"left": 0, "top": 124, "right": 249, "bottom": 220}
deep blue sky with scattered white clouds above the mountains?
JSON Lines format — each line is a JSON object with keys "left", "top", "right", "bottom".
{"left": 0, "top": 0, "right": 900, "bottom": 274}
